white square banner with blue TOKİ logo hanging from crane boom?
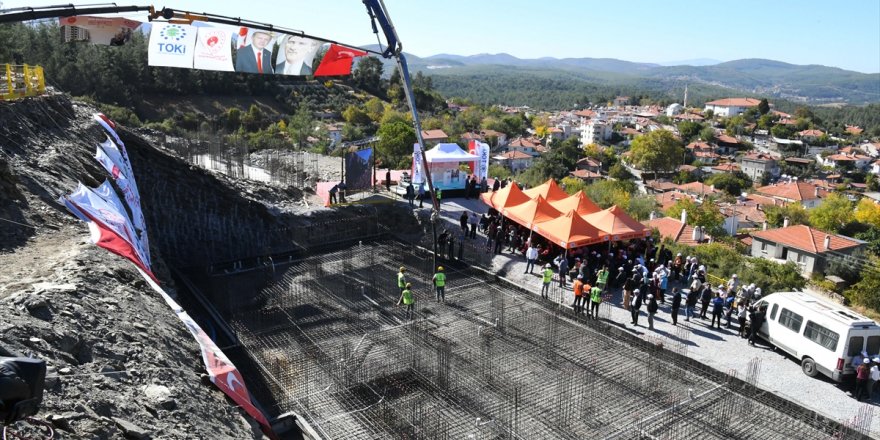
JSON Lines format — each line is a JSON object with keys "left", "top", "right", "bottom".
{"left": 147, "top": 23, "right": 197, "bottom": 69}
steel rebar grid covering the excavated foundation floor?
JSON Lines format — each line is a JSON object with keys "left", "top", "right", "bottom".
{"left": 210, "top": 242, "right": 870, "bottom": 439}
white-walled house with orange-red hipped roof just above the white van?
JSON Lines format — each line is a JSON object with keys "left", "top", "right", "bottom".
{"left": 752, "top": 225, "right": 866, "bottom": 276}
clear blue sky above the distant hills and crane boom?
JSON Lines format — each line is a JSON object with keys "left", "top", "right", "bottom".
{"left": 2, "top": 0, "right": 880, "bottom": 73}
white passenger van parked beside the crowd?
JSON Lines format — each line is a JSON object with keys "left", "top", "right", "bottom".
{"left": 755, "top": 292, "right": 880, "bottom": 382}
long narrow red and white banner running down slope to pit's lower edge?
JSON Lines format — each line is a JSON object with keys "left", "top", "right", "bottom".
{"left": 137, "top": 268, "right": 277, "bottom": 439}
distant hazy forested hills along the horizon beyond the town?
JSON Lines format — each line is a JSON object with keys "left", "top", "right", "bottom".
{"left": 366, "top": 46, "right": 880, "bottom": 108}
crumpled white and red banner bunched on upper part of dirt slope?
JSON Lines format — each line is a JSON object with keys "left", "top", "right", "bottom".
{"left": 60, "top": 182, "right": 153, "bottom": 277}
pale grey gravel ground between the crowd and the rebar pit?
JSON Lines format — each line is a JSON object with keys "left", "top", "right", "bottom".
{"left": 434, "top": 199, "right": 880, "bottom": 437}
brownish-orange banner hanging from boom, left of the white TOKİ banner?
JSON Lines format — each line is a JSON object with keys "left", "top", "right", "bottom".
{"left": 58, "top": 15, "right": 142, "bottom": 46}
